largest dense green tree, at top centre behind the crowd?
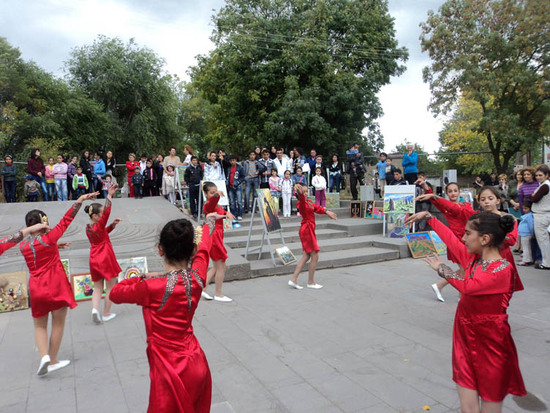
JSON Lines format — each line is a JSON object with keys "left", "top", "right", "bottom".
{"left": 190, "top": 0, "right": 407, "bottom": 153}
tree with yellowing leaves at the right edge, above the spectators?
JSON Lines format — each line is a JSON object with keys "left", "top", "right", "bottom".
{"left": 420, "top": 0, "right": 550, "bottom": 173}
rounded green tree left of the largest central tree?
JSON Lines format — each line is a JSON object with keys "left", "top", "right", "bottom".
{"left": 66, "top": 36, "right": 181, "bottom": 153}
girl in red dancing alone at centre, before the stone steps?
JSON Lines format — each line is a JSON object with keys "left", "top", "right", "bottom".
{"left": 288, "top": 184, "right": 338, "bottom": 290}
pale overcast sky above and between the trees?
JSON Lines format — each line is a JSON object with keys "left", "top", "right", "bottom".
{"left": 0, "top": 0, "right": 443, "bottom": 152}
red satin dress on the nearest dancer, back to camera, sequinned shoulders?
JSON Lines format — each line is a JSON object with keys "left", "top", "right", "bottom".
{"left": 110, "top": 225, "right": 212, "bottom": 413}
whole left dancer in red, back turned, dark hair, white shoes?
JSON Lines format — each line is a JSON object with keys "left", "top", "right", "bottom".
{"left": 19, "top": 192, "right": 99, "bottom": 376}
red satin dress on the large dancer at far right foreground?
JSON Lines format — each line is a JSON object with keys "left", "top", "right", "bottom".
{"left": 428, "top": 218, "right": 527, "bottom": 402}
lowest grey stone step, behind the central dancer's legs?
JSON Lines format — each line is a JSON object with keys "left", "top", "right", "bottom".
{"left": 250, "top": 247, "right": 399, "bottom": 276}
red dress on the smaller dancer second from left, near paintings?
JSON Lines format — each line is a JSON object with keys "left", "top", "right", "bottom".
{"left": 86, "top": 198, "right": 122, "bottom": 282}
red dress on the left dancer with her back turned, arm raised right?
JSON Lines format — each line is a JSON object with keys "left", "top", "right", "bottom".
{"left": 19, "top": 203, "right": 82, "bottom": 318}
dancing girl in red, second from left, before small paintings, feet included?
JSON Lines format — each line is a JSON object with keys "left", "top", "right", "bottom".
{"left": 84, "top": 184, "right": 122, "bottom": 324}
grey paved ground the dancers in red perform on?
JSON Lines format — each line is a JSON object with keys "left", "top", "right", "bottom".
{"left": 0, "top": 254, "right": 550, "bottom": 413}
